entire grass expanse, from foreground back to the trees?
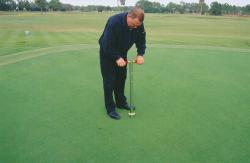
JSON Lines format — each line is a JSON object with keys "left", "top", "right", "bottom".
{"left": 0, "top": 13, "right": 250, "bottom": 163}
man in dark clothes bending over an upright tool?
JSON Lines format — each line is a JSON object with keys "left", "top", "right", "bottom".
{"left": 99, "top": 7, "right": 146, "bottom": 119}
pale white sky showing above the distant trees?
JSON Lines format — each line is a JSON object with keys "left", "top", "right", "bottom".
{"left": 60, "top": 0, "right": 250, "bottom": 6}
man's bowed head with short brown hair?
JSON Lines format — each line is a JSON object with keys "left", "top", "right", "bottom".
{"left": 127, "top": 6, "right": 144, "bottom": 28}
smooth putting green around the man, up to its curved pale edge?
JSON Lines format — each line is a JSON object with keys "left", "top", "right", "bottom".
{"left": 0, "top": 44, "right": 250, "bottom": 163}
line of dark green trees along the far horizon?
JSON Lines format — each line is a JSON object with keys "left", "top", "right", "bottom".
{"left": 0, "top": 0, "right": 250, "bottom": 15}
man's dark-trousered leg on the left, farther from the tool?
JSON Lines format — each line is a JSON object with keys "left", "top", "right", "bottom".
{"left": 100, "top": 58, "right": 116, "bottom": 113}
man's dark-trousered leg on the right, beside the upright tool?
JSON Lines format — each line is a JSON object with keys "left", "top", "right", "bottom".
{"left": 114, "top": 66, "right": 127, "bottom": 106}
